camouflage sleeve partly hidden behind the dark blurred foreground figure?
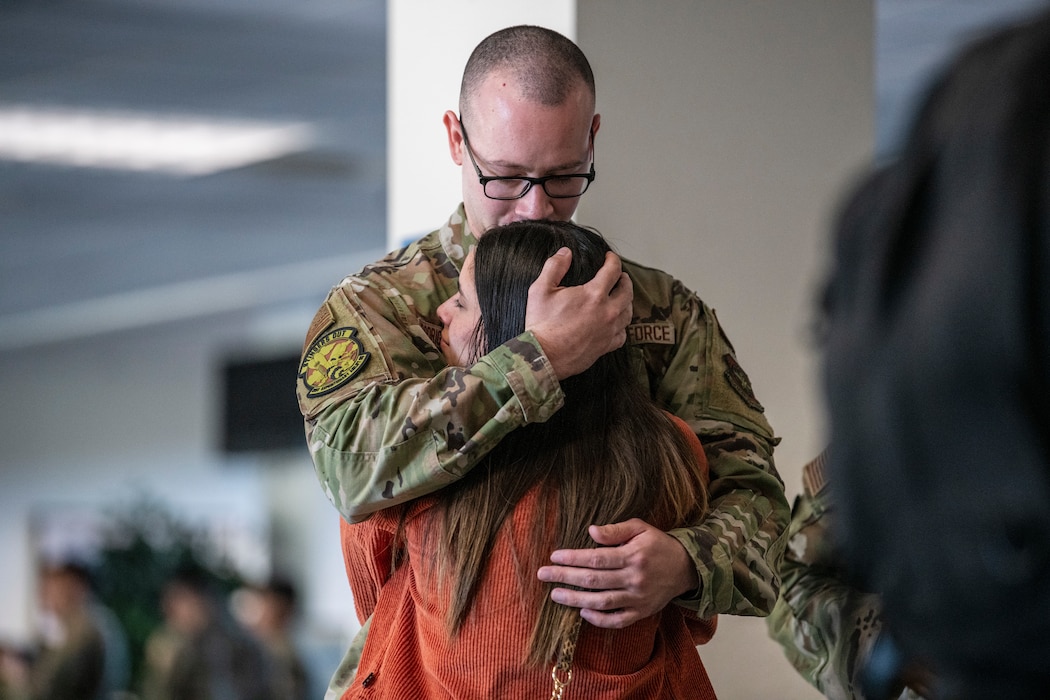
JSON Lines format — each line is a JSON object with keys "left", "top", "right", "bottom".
{"left": 765, "top": 452, "right": 922, "bottom": 700}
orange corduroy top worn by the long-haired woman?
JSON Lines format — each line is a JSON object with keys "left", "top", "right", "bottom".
{"left": 340, "top": 413, "right": 717, "bottom": 700}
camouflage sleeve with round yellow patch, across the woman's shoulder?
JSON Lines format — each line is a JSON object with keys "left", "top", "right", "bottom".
{"left": 297, "top": 278, "right": 563, "bottom": 523}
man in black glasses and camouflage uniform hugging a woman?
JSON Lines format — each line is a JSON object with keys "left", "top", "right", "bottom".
{"left": 297, "top": 26, "right": 789, "bottom": 685}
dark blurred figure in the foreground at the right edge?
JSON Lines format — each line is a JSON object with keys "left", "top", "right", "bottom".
{"left": 824, "top": 6, "right": 1050, "bottom": 699}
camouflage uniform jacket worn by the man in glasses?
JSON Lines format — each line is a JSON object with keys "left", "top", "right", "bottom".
{"left": 296, "top": 205, "right": 789, "bottom": 617}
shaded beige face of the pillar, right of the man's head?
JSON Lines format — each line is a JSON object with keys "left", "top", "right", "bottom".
{"left": 576, "top": 0, "right": 875, "bottom": 700}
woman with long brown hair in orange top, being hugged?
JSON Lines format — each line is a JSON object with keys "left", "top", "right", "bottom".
{"left": 342, "top": 221, "right": 714, "bottom": 699}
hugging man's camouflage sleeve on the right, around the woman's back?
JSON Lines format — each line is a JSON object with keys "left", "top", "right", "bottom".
{"left": 655, "top": 289, "right": 790, "bottom": 617}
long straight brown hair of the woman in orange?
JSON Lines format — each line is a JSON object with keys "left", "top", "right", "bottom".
{"left": 431, "top": 221, "right": 707, "bottom": 664}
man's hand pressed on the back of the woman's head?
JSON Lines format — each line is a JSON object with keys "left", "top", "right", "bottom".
{"left": 525, "top": 248, "right": 634, "bottom": 380}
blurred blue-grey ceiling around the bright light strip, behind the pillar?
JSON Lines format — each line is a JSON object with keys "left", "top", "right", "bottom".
{"left": 0, "top": 0, "right": 1046, "bottom": 352}
